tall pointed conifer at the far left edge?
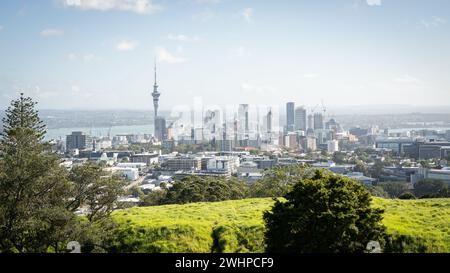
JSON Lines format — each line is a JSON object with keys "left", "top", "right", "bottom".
{"left": 0, "top": 94, "right": 76, "bottom": 252}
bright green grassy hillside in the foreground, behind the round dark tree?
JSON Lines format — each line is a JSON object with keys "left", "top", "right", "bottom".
{"left": 113, "top": 198, "right": 450, "bottom": 253}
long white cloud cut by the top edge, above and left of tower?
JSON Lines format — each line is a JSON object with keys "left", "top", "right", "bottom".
{"left": 60, "top": 0, "right": 162, "bottom": 14}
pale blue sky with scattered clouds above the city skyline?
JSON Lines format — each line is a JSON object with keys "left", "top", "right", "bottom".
{"left": 0, "top": 0, "right": 450, "bottom": 110}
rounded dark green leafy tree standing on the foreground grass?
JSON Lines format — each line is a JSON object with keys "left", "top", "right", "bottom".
{"left": 264, "top": 170, "right": 386, "bottom": 253}
